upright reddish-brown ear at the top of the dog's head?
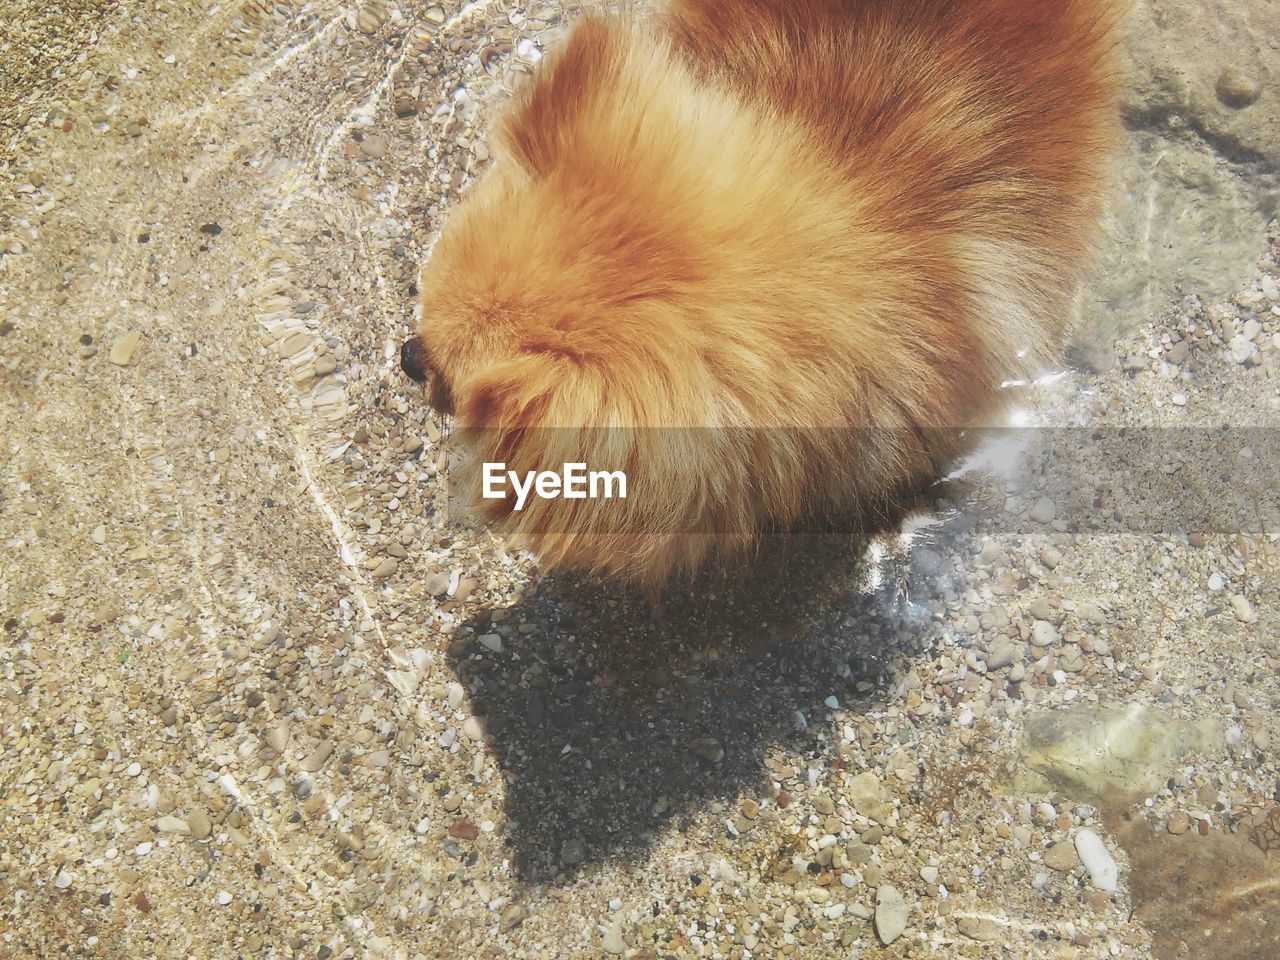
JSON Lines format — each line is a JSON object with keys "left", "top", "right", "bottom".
{"left": 502, "top": 17, "right": 625, "bottom": 177}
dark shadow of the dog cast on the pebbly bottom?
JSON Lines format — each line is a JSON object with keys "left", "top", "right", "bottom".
{"left": 449, "top": 514, "right": 962, "bottom": 882}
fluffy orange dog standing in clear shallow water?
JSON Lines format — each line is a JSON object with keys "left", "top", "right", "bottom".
{"left": 403, "top": 0, "right": 1115, "bottom": 588}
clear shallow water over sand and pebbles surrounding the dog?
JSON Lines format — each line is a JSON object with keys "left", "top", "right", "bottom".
{"left": 0, "top": 1, "right": 1280, "bottom": 957}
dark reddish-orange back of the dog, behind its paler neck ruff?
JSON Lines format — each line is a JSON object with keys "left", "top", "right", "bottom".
{"left": 664, "top": 0, "right": 1121, "bottom": 367}
